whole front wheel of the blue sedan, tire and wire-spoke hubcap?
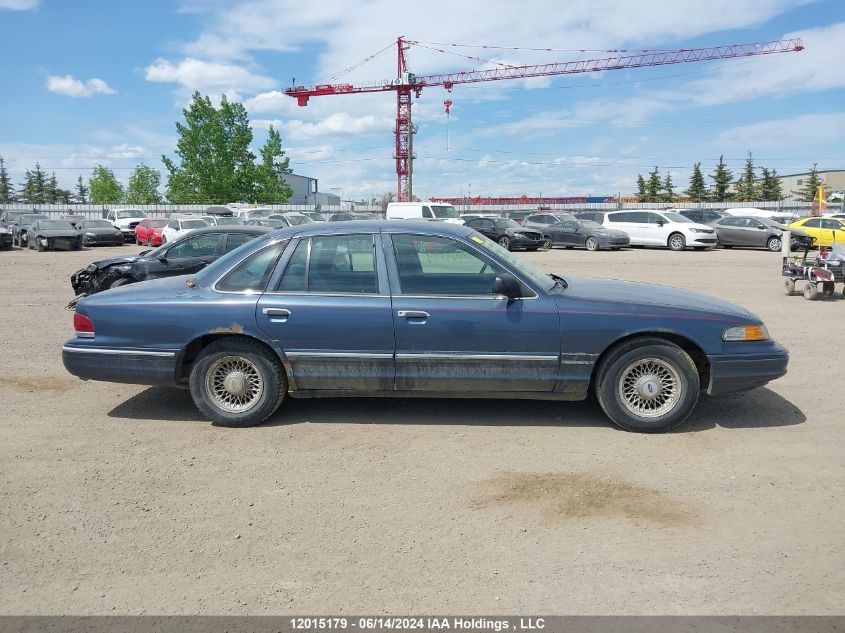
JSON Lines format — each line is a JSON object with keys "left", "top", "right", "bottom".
{"left": 596, "top": 339, "right": 700, "bottom": 433}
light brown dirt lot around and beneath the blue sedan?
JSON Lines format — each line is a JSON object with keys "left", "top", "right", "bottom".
{"left": 0, "top": 242, "right": 845, "bottom": 614}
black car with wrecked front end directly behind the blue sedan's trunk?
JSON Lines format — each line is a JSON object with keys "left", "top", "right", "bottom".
{"left": 70, "top": 226, "right": 270, "bottom": 296}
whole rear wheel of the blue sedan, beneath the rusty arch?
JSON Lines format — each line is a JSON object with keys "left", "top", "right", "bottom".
{"left": 189, "top": 339, "right": 287, "bottom": 427}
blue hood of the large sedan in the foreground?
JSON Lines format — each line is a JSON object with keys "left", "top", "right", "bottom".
{"left": 563, "top": 277, "right": 756, "bottom": 319}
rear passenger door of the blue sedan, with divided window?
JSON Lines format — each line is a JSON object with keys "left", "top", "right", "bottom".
{"left": 256, "top": 233, "right": 394, "bottom": 391}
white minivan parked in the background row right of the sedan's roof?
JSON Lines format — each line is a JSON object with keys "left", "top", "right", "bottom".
{"left": 602, "top": 209, "right": 718, "bottom": 251}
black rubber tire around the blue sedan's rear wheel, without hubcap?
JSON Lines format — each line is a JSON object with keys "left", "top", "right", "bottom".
{"left": 189, "top": 338, "right": 287, "bottom": 427}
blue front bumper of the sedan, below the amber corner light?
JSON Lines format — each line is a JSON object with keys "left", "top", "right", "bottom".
{"left": 707, "top": 343, "right": 789, "bottom": 396}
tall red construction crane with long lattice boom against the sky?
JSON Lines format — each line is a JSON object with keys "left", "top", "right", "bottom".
{"left": 285, "top": 37, "right": 804, "bottom": 202}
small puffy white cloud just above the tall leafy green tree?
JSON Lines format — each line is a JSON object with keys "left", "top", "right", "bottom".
{"left": 144, "top": 57, "right": 276, "bottom": 96}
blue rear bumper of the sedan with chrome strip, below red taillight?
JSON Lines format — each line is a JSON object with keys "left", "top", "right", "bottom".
{"left": 62, "top": 338, "right": 179, "bottom": 386}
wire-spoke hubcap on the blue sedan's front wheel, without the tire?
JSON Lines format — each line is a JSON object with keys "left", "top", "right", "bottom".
{"left": 619, "top": 358, "right": 683, "bottom": 418}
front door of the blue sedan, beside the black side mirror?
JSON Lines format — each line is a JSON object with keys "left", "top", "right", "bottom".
{"left": 384, "top": 234, "right": 560, "bottom": 393}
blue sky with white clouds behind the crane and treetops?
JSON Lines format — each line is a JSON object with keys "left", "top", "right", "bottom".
{"left": 0, "top": 0, "right": 845, "bottom": 199}
